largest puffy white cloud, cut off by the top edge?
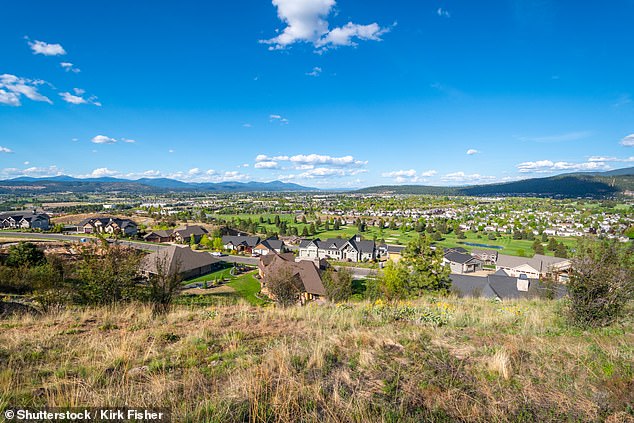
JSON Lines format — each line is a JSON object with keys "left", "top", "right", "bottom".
{"left": 260, "top": 0, "right": 388, "bottom": 50}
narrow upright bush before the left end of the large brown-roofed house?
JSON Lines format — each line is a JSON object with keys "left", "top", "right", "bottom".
{"left": 148, "top": 252, "right": 180, "bottom": 316}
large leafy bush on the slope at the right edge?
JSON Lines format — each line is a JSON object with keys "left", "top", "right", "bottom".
{"left": 567, "top": 239, "right": 634, "bottom": 327}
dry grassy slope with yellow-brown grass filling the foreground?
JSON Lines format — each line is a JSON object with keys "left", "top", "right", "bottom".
{"left": 0, "top": 298, "right": 634, "bottom": 422}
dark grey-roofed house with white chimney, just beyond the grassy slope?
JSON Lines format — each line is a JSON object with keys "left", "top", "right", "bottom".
{"left": 450, "top": 271, "right": 567, "bottom": 300}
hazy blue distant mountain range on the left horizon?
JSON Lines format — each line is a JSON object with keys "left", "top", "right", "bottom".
{"left": 0, "top": 175, "right": 317, "bottom": 194}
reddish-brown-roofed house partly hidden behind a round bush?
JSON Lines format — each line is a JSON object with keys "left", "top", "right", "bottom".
{"left": 258, "top": 253, "right": 326, "bottom": 304}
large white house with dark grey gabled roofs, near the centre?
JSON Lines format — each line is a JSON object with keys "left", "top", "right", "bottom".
{"left": 299, "top": 235, "right": 377, "bottom": 262}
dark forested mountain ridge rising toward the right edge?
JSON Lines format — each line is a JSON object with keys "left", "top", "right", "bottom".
{"left": 356, "top": 167, "right": 634, "bottom": 197}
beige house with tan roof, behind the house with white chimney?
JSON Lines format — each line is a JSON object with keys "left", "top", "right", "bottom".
{"left": 495, "top": 254, "right": 572, "bottom": 282}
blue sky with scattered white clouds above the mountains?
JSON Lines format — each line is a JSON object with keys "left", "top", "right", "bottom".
{"left": 0, "top": 0, "right": 634, "bottom": 187}
